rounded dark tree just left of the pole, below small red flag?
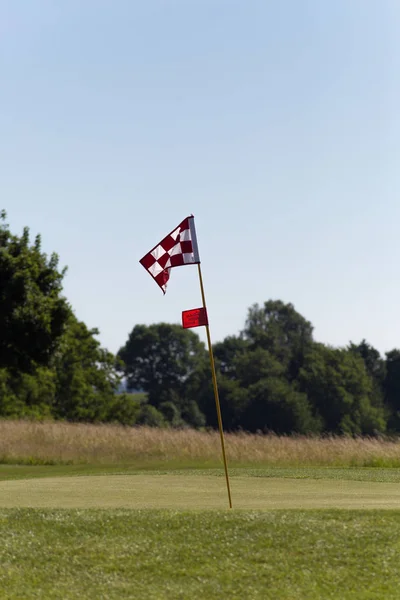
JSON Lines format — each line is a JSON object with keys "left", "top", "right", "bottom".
{"left": 118, "top": 323, "right": 207, "bottom": 425}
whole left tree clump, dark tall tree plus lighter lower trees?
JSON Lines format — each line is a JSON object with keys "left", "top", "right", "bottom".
{"left": 0, "top": 211, "right": 126, "bottom": 421}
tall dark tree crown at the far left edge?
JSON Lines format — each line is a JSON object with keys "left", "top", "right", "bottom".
{"left": 0, "top": 211, "right": 71, "bottom": 372}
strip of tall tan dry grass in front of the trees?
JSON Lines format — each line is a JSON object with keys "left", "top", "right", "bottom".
{"left": 0, "top": 420, "right": 400, "bottom": 467}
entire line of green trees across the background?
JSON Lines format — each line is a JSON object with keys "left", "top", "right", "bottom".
{"left": 0, "top": 211, "right": 400, "bottom": 435}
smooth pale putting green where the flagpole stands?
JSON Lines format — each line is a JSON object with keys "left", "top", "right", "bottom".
{"left": 0, "top": 474, "right": 400, "bottom": 510}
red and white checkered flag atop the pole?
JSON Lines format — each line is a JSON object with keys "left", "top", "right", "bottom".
{"left": 140, "top": 216, "right": 200, "bottom": 294}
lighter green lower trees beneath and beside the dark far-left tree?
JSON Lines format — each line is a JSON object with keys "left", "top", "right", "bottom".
{"left": 0, "top": 314, "right": 124, "bottom": 424}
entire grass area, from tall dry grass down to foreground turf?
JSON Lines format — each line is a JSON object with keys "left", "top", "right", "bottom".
{"left": 0, "top": 422, "right": 400, "bottom": 600}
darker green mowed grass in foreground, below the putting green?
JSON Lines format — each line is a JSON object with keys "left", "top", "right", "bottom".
{"left": 0, "top": 509, "right": 400, "bottom": 600}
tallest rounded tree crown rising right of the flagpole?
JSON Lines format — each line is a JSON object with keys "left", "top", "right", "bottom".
{"left": 243, "top": 300, "right": 313, "bottom": 381}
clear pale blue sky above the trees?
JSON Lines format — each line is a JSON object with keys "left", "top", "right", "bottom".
{"left": 0, "top": 0, "right": 400, "bottom": 352}
